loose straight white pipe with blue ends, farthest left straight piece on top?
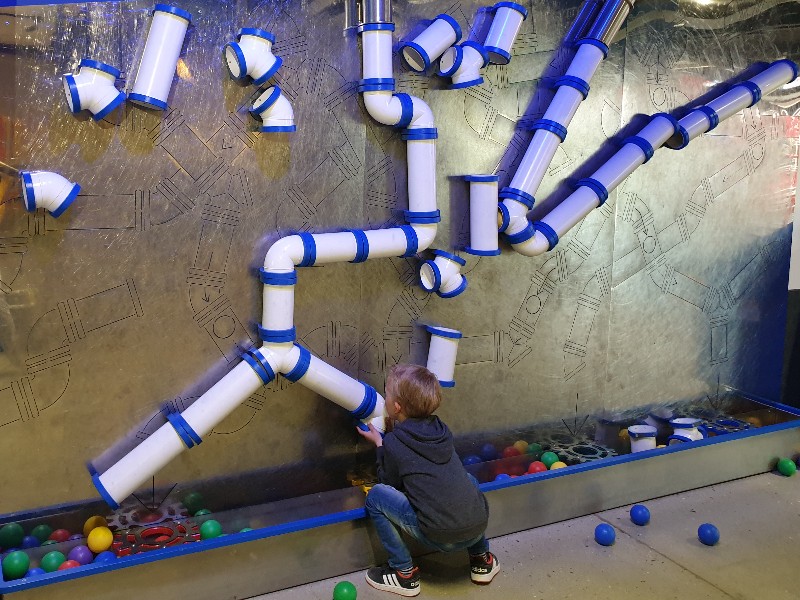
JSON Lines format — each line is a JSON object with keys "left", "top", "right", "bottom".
{"left": 128, "top": 4, "right": 192, "bottom": 110}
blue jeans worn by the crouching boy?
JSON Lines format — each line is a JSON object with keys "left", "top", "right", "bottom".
{"left": 365, "top": 480, "right": 489, "bottom": 571}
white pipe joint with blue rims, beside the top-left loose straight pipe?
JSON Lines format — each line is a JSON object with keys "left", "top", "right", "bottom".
{"left": 64, "top": 58, "right": 125, "bottom": 121}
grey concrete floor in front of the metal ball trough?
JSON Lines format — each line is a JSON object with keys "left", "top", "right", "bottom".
{"left": 258, "top": 473, "right": 800, "bottom": 600}
